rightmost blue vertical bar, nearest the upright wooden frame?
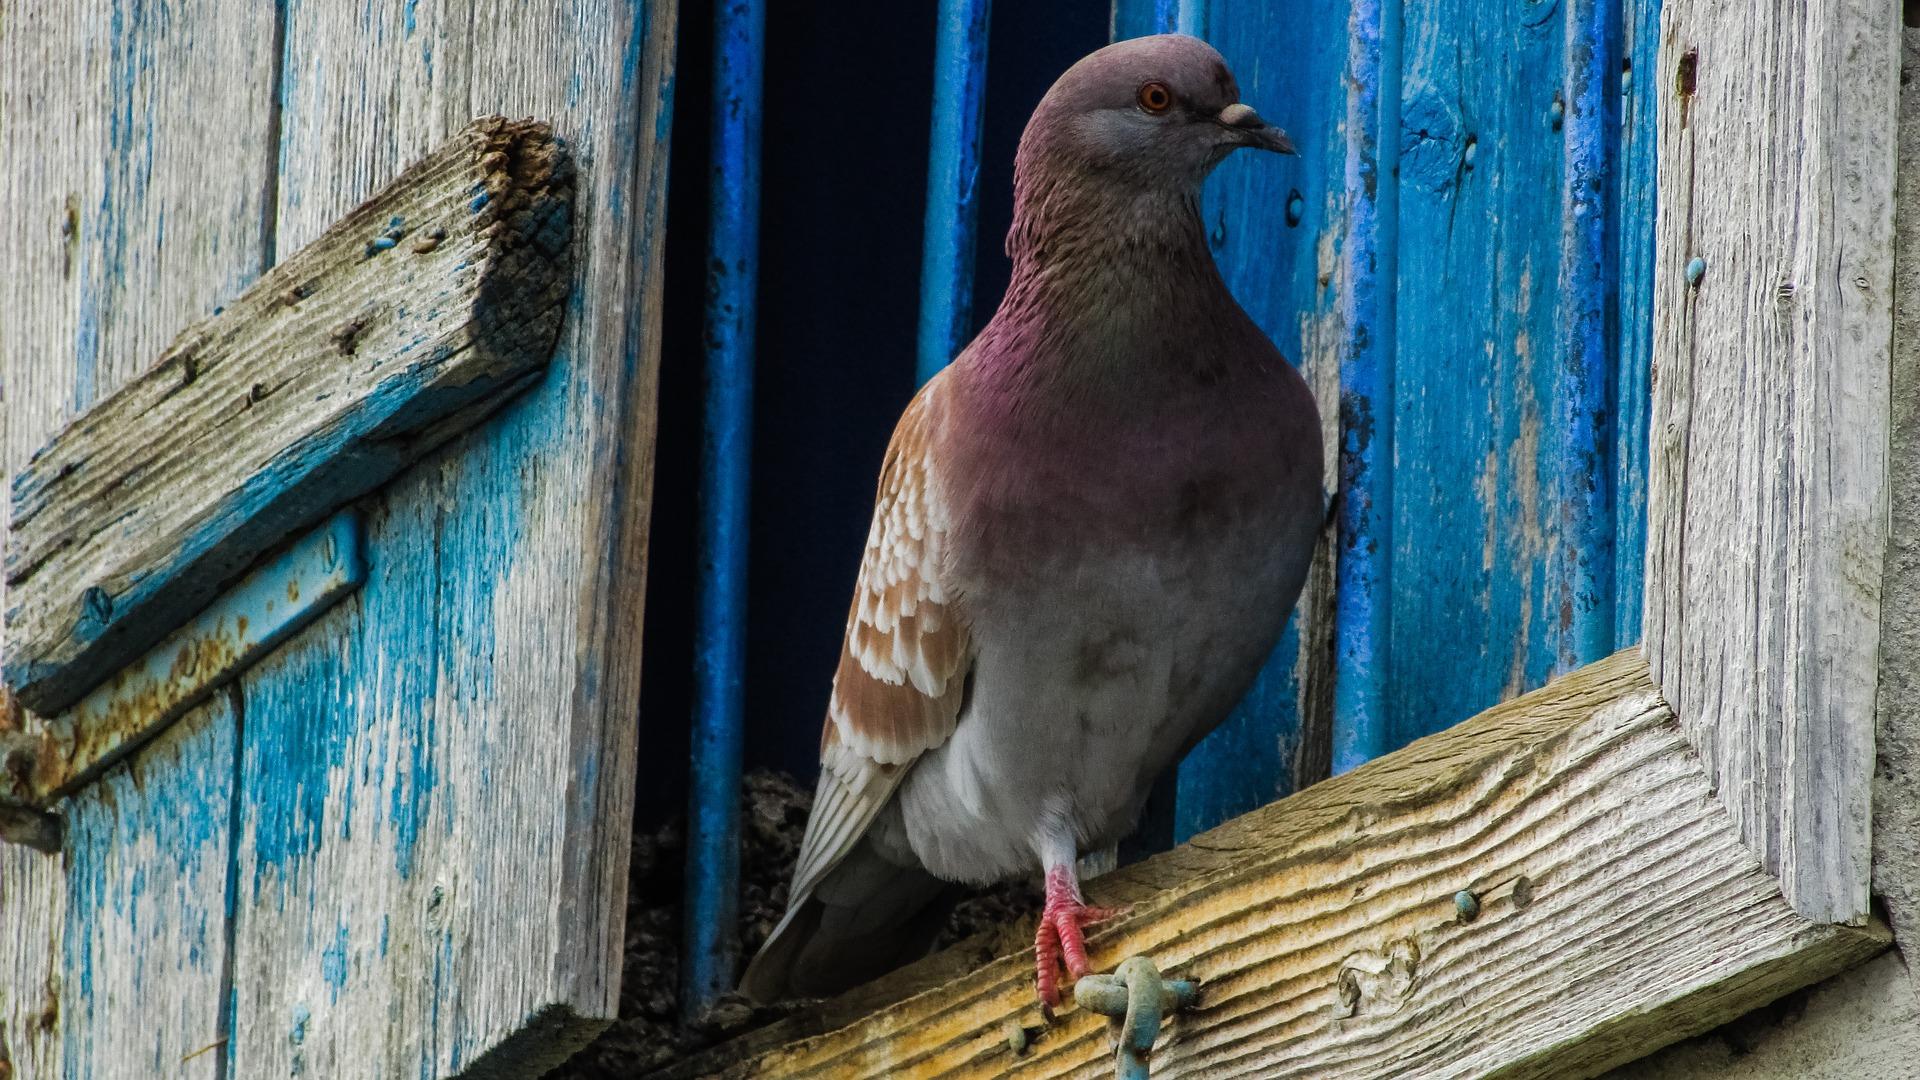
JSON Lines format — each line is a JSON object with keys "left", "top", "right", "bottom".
{"left": 1549, "top": 0, "right": 1620, "bottom": 675}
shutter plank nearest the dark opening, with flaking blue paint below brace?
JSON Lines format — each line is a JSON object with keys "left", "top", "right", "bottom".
{"left": 228, "top": 0, "right": 674, "bottom": 1078}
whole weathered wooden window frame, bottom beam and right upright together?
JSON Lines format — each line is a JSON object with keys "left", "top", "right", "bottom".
{"left": 683, "top": 0, "right": 1920, "bottom": 1078}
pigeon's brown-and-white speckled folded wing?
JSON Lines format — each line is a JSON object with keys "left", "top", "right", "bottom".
{"left": 789, "top": 379, "right": 972, "bottom": 907}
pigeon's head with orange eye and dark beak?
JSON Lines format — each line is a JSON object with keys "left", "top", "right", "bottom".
{"left": 1020, "top": 35, "right": 1294, "bottom": 190}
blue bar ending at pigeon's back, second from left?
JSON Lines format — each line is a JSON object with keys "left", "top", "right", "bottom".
{"left": 916, "top": 0, "right": 993, "bottom": 382}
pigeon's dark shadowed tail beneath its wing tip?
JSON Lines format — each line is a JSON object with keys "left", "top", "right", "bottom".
{"left": 739, "top": 840, "right": 954, "bottom": 1005}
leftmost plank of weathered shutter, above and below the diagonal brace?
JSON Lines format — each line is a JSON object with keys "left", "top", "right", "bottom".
{"left": 0, "top": 0, "right": 273, "bottom": 1080}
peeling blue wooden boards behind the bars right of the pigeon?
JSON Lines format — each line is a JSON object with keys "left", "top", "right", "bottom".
{"left": 1116, "top": 0, "right": 1659, "bottom": 822}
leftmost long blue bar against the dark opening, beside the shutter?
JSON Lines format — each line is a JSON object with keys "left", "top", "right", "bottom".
{"left": 680, "top": 0, "right": 766, "bottom": 1019}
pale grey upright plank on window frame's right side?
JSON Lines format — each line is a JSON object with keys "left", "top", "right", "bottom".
{"left": 1645, "top": 0, "right": 1901, "bottom": 920}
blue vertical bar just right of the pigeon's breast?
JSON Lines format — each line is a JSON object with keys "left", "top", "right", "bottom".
{"left": 1332, "top": 0, "right": 1400, "bottom": 773}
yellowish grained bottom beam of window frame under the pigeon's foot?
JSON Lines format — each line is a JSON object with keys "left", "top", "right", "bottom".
{"left": 664, "top": 653, "right": 1887, "bottom": 1080}
